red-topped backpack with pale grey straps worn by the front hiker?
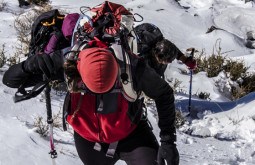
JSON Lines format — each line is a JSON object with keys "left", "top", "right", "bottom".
{"left": 65, "top": 1, "right": 143, "bottom": 102}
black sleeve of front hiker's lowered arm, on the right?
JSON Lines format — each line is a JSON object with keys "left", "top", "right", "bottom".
{"left": 135, "top": 60, "right": 175, "bottom": 134}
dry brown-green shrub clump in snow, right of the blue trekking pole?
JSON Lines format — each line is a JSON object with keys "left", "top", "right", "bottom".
{"left": 194, "top": 39, "right": 252, "bottom": 100}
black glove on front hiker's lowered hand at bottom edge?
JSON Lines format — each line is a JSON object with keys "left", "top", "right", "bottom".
{"left": 158, "top": 135, "right": 179, "bottom": 165}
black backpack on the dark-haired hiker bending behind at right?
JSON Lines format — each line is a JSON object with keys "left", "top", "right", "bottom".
{"left": 135, "top": 23, "right": 163, "bottom": 54}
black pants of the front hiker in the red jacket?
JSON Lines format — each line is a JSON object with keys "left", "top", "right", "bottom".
{"left": 74, "top": 121, "right": 159, "bottom": 165}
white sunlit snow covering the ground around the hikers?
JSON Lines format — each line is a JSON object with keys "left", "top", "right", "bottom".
{"left": 0, "top": 0, "right": 255, "bottom": 165}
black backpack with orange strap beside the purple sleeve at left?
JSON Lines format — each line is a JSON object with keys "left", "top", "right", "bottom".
{"left": 28, "top": 9, "right": 66, "bottom": 56}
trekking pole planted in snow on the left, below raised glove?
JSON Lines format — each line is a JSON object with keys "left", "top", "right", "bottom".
{"left": 45, "top": 84, "right": 57, "bottom": 165}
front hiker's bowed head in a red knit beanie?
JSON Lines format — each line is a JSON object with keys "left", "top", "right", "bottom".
{"left": 77, "top": 47, "right": 119, "bottom": 93}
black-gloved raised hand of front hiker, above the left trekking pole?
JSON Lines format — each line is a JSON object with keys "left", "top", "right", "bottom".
{"left": 23, "top": 51, "right": 63, "bottom": 79}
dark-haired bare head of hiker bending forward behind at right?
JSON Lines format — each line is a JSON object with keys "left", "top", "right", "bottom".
{"left": 152, "top": 38, "right": 180, "bottom": 64}
